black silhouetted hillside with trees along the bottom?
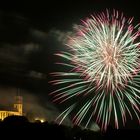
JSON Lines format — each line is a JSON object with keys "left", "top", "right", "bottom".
{"left": 0, "top": 116, "right": 140, "bottom": 140}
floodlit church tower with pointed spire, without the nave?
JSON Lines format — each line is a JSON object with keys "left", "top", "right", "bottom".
{"left": 14, "top": 89, "right": 23, "bottom": 116}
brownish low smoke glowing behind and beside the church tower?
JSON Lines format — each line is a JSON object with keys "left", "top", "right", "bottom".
{"left": 0, "top": 86, "right": 71, "bottom": 125}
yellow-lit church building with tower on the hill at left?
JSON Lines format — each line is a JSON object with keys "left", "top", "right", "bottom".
{"left": 0, "top": 89, "right": 23, "bottom": 120}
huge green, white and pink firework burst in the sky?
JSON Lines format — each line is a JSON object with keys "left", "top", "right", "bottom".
{"left": 51, "top": 10, "right": 140, "bottom": 130}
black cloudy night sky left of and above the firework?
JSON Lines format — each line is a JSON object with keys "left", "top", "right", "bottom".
{"left": 0, "top": 0, "right": 140, "bottom": 129}
